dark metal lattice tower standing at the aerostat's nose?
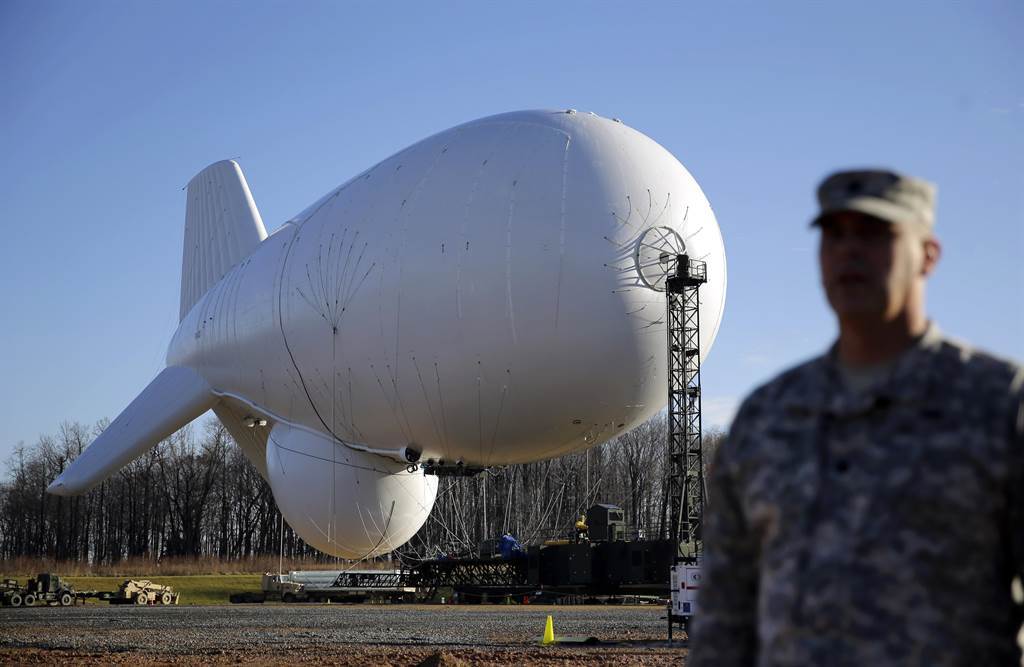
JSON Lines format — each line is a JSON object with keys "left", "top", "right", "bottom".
{"left": 666, "top": 255, "right": 708, "bottom": 562}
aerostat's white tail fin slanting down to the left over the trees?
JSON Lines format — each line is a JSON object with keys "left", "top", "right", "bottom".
{"left": 46, "top": 366, "right": 217, "bottom": 496}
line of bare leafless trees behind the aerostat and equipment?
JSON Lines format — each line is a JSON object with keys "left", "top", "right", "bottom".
{"left": 0, "top": 415, "right": 722, "bottom": 565}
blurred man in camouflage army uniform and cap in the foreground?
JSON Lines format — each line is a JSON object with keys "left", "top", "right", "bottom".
{"left": 690, "top": 170, "right": 1024, "bottom": 667}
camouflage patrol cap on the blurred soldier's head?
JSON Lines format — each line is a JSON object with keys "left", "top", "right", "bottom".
{"left": 811, "top": 169, "right": 936, "bottom": 228}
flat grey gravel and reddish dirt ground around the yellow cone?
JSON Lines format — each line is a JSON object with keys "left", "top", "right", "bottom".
{"left": 0, "top": 605, "right": 686, "bottom": 665}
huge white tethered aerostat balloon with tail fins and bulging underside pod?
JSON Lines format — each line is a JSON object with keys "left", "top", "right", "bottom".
{"left": 49, "top": 110, "right": 726, "bottom": 557}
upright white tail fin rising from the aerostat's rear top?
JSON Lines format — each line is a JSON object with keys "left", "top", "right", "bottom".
{"left": 178, "top": 160, "right": 266, "bottom": 320}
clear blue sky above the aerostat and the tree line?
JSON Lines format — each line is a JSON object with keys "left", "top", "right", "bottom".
{"left": 0, "top": 0, "right": 1024, "bottom": 460}
